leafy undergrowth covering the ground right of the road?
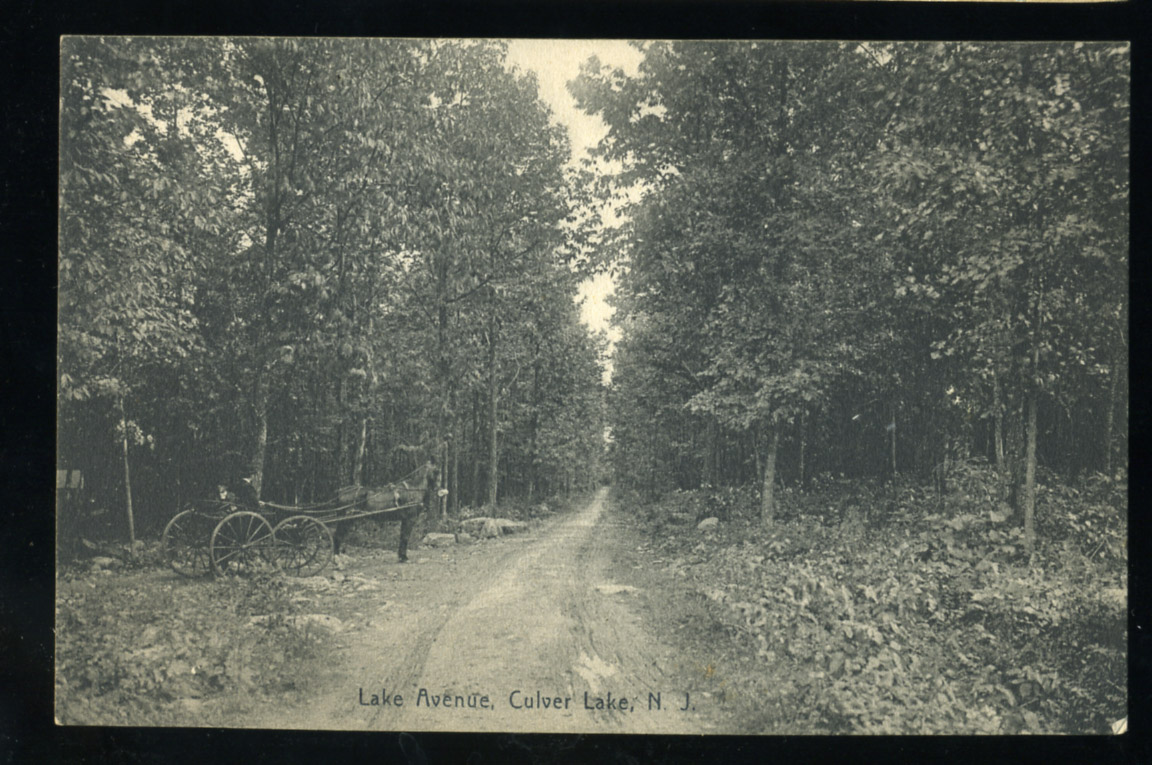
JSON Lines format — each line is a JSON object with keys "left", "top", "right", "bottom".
{"left": 621, "top": 469, "right": 1128, "bottom": 734}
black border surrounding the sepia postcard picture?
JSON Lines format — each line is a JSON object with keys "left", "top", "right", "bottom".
{"left": 0, "top": 0, "right": 1152, "bottom": 764}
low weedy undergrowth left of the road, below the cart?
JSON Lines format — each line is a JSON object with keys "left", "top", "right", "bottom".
{"left": 55, "top": 566, "right": 324, "bottom": 726}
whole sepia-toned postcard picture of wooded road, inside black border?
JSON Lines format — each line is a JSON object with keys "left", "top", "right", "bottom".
{"left": 54, "top": 37, "right": 1130, "bottom": 736}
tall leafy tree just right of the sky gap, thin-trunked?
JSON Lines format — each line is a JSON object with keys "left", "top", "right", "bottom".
{"left": 574, "top": 44, "right": 889, "bottom": 523}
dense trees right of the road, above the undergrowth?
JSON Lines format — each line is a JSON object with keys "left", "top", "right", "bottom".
{"left": 573, "top": 43, "right": 1129, "bottom": 546}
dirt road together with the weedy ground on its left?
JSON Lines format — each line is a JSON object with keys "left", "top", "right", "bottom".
{"left": 58, "top": 490, "right": 752, "bottom": 733}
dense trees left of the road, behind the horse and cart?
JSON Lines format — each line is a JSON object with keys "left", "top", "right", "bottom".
{"left": 58, "top": 38, "right": 604, "bottom": 539}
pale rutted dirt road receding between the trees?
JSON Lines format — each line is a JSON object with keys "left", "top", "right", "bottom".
{"left": 243, "top": 490, "right": 726, "bottom": 733}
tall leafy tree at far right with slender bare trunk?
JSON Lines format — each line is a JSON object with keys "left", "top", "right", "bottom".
{"left": 877, "top": 45, "right": 1128, "bottom": 550}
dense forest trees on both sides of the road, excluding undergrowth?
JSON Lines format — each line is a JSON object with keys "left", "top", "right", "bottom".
{"left": 58, "top": 38, "right": 1129, "bottom": 562}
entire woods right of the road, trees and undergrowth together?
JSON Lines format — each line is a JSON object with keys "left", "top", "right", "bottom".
{"left": 571, "top": 43, "right": 1130, "bottom": 734}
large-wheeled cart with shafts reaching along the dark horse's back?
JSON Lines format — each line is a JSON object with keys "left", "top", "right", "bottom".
{"left": 161, "top": 484, "right": 423, "bottom": 576}
